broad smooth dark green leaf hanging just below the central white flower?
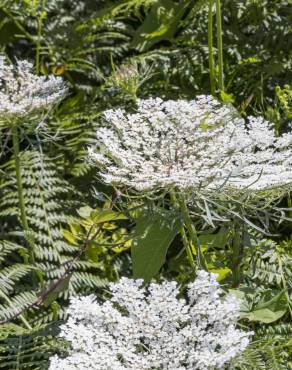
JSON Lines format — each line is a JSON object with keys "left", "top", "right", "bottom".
{"left": 131, "top": 213, "right": 181, "bottom": 281}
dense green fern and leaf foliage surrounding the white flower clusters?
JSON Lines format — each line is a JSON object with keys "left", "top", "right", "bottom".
{"left": 0, "top": 0, "right": 292, "bottom": 370}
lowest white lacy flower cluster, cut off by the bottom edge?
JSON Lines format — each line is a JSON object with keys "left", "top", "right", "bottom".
{"left": 49, "top": 271, "right": 252, "bottom": 370}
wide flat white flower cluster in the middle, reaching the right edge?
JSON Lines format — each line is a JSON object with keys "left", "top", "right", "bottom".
{"left": 89, "top": 96, "right": 292, "bottom": 191}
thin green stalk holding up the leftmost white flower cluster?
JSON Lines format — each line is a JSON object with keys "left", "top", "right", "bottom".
{"left": 12, "top": 125, "right": 34, "bottom": 263}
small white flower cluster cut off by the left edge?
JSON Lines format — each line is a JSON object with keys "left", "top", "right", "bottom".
{"left": 0, "top": 58, "right": 67, "bottom": 121}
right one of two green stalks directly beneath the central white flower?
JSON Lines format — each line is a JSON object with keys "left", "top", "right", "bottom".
{"left": 179, "top": 196, "right": 208, "bottom": 271}
